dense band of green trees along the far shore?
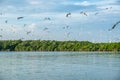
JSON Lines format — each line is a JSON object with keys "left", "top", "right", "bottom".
{"left": 0, "top": 40, "right": 120, "bottom": 51}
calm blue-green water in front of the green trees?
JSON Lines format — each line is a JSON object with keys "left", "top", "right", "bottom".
{"left": 0, "top": 52, "right": 120, "bottom": 80}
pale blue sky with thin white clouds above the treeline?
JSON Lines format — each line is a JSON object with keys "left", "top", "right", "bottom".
{"left": 0, "top": 0, "right": 120, "bottom": 42}
